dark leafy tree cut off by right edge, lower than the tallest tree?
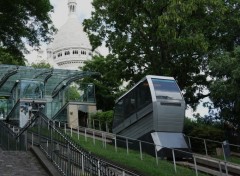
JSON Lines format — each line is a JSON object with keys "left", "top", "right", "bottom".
{"left": 209, "top": 46, "right": 240, "bottom": 132}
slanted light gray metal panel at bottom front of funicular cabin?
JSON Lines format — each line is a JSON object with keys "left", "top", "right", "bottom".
{"left": 151, "top": 132, "right": 188, "bottom": 151}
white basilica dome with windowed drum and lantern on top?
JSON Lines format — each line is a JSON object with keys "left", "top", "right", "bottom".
{"left": 47, "top": 0, "right": 99, "bottom": 70}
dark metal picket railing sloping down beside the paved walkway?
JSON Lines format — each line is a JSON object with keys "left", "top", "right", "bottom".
{"left": 28, "top": 113, "right": 138, "bottom": 176}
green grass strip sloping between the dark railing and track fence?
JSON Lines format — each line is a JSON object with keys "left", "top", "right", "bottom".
{"left": 68, "top": 133, "right": 204, "bottom": 176}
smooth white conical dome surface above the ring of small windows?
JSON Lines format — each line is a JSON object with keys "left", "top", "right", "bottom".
{"left": 51, "top": 15, "right": 92, "bottom": 51}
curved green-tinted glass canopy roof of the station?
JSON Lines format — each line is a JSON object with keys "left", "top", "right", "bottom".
{"left": 0, "top": 64, "right": 97, "bottom": 96}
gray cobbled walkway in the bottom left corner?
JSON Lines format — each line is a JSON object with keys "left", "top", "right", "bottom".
{"left": 0, "top": 148, "right": 48, "bottom": 176}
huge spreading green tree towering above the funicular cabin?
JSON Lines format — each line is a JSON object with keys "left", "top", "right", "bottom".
{"left": 84, "top": 0, "right": 240, "bottom": 107}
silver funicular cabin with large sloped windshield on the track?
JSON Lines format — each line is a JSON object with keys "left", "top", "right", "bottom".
{"left": 113, "top": 75, "right": 188, "bottom": 156}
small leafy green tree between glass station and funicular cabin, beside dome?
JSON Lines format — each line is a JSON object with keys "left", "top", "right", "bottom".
{"left": 82, "top": 55, "right": 122, "bottom": 111}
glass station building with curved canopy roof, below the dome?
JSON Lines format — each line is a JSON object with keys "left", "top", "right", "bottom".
{"left": 0, "top": 65, "right": 96, "bottom": 128}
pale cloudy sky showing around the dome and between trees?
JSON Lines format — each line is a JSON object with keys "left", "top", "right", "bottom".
{"left": 25, "top": 0, "right": 208, "bottom": 117}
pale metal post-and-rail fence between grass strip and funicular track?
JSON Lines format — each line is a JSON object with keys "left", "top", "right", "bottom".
{"left": 53, "top": 121, "right": 240, "bottom": 175}
